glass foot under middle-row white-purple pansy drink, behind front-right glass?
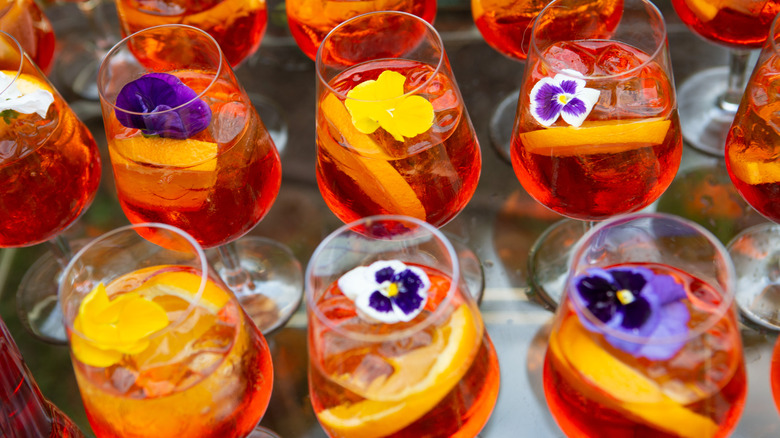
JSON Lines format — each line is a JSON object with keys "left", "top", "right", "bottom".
{"left": 528, "top": 219, "right": 589, "bottom": 310}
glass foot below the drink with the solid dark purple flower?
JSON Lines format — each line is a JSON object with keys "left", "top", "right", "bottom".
{"left": 210, "top": 236, "right": 303, "bottom": 336}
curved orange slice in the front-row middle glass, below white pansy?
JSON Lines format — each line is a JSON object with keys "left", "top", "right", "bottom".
{"left": 317, "top": 304, "right": 480, "bottom": 438}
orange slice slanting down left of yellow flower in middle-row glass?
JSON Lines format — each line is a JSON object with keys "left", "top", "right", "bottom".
{"left": 319, "top": 94, "right": 426, "bottom": 220}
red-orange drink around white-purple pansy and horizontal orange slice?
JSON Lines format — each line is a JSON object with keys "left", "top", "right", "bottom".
{"left": 511, "top": 41, "right": 682, "bottom": 220}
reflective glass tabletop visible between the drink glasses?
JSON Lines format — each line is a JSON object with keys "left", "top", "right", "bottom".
{"left": 0, "top": 0, "right": 780, "bottom": 438}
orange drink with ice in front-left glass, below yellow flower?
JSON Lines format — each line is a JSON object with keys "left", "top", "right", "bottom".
{"left": 73, "top": 267, "right": 273, "bottom": 438}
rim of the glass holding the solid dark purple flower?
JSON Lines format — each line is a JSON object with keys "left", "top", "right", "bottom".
{"left": 97, "top": 23, "right": 226, "bottom": 116}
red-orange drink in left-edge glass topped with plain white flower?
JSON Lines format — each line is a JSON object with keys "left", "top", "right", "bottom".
{"left": 0, "top": 96, "right": 100, "bottom": 247}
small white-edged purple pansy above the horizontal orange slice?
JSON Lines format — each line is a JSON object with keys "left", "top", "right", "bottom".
{"left": 531, "top": 69, "right": 600, "bottom": 126}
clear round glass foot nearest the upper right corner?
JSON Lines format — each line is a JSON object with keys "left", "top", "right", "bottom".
{"left": 677, "top": 67, "right": 737, "bottom": 157}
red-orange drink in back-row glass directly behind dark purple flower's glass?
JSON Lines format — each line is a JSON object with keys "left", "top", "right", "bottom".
{"left": 116, "top": 0, "right": 268, "bottom": 67}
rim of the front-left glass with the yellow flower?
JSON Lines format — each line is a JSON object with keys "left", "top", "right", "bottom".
{"left": 57, "top": 222, "right": 210, "bottom": 342}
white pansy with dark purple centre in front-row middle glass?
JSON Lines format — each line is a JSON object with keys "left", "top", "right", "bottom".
{"left": 338, "top": 260, "right": 431, "bottom": 324}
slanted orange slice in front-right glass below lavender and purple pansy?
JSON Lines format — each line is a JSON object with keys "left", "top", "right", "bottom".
{"left": 550, "top": 316, "right": 718, "bottom": 438}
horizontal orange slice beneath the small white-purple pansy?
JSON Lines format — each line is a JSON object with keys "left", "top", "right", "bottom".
{"left": 519, "top": 118, "right": 672, "bottom": 156}
